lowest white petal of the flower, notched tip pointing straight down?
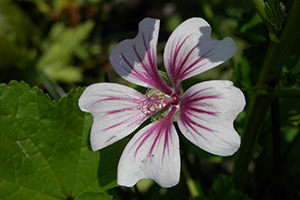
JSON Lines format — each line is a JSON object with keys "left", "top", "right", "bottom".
{"left": 118, "top": 107, "right": 180, "bottom": 187}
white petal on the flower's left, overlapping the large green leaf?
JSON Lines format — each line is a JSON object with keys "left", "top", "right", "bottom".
{"left": 79, "top": 83, "right": 149, "bottom": 151}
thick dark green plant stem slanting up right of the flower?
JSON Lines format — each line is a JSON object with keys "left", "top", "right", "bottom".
{"left": 233, "top": 0, "right": 300, "bottom": 190}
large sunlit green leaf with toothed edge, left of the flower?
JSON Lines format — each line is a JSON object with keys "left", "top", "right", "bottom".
{"left": 0, "top": 81, "right": 116, "bottom": 200}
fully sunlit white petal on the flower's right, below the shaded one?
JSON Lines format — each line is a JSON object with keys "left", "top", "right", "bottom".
{"left": 178, "top": 81, "right": 245, "bottom": 156}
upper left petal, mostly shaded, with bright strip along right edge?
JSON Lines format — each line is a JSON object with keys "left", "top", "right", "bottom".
{"left": 109, "top": 18, "right": 171, "bottom": 94}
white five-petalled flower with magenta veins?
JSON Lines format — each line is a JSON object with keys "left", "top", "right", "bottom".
{"left": 79, "top": 18, "right": 245, "bottom": 187}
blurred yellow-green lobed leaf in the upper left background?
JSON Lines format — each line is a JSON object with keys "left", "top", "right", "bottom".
{"left": 37, "top": 21, "right": 94, "bottom": 83}
